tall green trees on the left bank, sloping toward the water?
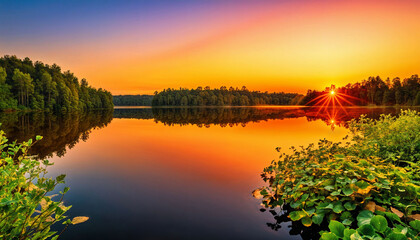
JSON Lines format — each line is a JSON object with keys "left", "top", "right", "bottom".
{"left": 0, "top": 55, "right": 113, "bottom": 112}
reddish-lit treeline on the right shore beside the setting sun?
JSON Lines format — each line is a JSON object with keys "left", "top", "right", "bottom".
{"left": 302, "top": 75, "right": 420, "bottom": 106}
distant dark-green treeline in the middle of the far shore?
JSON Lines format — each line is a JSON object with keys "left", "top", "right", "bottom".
{"left": 152, "top": 86, "right": 303, "bottom": 106}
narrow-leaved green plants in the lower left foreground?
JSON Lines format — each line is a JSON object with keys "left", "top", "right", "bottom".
{"left": 0, "top": 127, "right": 88, "bottom": 240}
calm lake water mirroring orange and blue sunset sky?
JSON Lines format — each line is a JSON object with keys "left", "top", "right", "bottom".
{"left": 0, "top": 107, "right": 414, "bottom": 240}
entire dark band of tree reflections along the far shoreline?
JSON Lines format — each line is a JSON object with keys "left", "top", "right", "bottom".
{"left": 0, "top": 107, "right": 412, "bottom": 158}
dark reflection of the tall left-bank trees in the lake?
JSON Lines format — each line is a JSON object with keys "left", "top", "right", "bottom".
{"left": 0, "top": 110, "right": 112, "bottom": 158}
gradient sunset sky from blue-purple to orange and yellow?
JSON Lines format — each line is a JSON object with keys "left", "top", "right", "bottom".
{"left": 0, "top": 0, "right": 420, "bottom": 94}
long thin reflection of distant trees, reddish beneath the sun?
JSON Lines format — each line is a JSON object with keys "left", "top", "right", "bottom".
{"left": 114, "top": 107, "right": 412, "bottom": 129}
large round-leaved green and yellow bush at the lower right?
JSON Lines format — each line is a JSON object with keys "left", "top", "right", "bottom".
{"left": 254, "top": 111, "right": 420, "bottom": 239}
